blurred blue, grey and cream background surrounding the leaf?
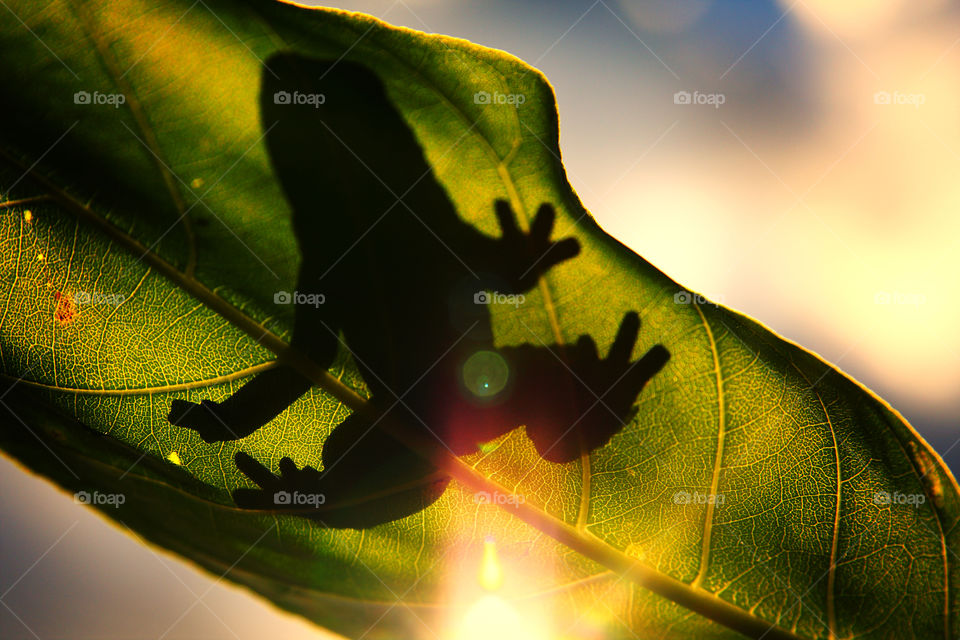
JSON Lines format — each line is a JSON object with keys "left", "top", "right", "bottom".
{"left": 0, "top": 0, "right": 960, "bottom": 640}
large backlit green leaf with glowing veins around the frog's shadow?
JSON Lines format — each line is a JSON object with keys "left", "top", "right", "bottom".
{"left": 0, "top": 0, "right": 960, "bottom": 638}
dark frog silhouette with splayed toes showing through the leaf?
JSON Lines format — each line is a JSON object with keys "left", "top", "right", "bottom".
{"left": 169, "top": 54, "right": 669, "bottom": 528}
